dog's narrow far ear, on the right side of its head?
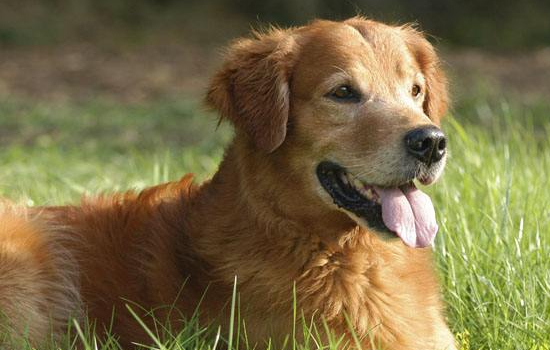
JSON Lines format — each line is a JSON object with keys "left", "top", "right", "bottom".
{"left": 401, "top": 26, "right": 449, "bottom": 124}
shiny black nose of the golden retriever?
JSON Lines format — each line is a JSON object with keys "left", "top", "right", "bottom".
{"left": 405, "top": 126, "right": 447, "bottom": 165}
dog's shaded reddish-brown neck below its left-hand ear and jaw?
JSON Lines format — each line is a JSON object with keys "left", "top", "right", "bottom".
{"left": 185, "top": 138, "right": 356, "bottom": 272}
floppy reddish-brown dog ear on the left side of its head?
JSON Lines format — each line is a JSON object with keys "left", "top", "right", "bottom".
{"left": 206, "top": 29, "right": 296, "bottom": 152}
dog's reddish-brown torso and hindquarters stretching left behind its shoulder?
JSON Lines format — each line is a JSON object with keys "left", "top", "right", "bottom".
{"left": 0, "top": 176, "right": 213, "bottom": 344}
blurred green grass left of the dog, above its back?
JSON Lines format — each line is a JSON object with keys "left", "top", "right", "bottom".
{"left": 0, "top": 101, "right": 231, "bottom": 204}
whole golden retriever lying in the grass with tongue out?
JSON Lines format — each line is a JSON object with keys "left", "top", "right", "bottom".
{"left": 0, "top": 17, "right": 455, "bottom": 350}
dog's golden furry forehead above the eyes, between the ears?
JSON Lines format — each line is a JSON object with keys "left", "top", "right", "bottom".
{"left": 296, "top": 21, "right": 417, "bottom": 92}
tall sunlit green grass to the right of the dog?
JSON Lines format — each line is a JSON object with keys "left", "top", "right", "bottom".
{"left": 433, "top": 103, "right": 550, "bottom": 349}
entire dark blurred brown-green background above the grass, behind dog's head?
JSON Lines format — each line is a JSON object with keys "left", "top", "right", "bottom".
{"left": 0, "top": 0, "right": 550, "bottom": 102}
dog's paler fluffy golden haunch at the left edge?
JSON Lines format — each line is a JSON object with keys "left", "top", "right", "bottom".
{"left": 0, "top": 202, "right": 82, "bottom": 344}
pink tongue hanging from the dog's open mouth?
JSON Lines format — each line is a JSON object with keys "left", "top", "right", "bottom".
{"left": 375, "top": 186, "right": 437, "bottom": 248}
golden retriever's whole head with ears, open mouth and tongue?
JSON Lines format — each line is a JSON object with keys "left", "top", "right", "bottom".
{"left": 207, "top": 17, "right": 447, "bottom": 247}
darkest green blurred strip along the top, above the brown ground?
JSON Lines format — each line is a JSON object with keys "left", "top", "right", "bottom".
{"left": 0, "top": 0, "right": 550, "bottom": 50}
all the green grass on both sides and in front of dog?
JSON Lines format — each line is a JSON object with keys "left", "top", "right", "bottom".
{"left": 0, "top": 95, "right": 550, "bottom": 350}
